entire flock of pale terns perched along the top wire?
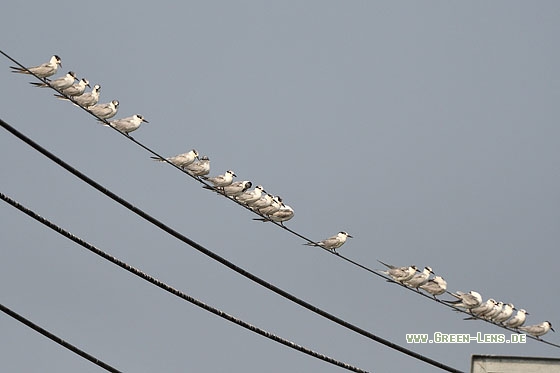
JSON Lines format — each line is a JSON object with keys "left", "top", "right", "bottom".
{"left": 11, "top": 55, "right": 554, "bottom": 338}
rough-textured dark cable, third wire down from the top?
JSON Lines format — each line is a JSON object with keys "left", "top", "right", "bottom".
{"left": 0, "top": 192, "right": 367, "bottom": 373}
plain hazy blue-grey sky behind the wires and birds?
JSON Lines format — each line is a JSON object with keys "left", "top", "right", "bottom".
{"left": 0, "top": 1, "right": 560, "bottom": 372}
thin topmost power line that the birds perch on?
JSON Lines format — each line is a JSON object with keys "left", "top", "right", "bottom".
{"left": 0, "top": 50, "right": 560, "bottom": 348}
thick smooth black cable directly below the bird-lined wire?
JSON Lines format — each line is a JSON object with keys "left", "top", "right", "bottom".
{"left": 0, "top": 119, "right": 460, "bottom": 372}
